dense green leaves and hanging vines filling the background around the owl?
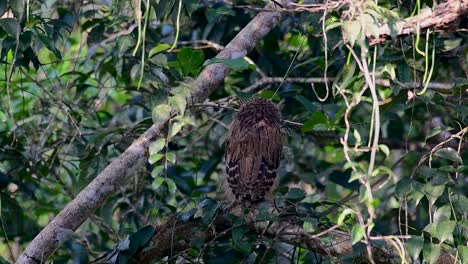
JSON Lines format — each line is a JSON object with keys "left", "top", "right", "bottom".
{"left": 0, "top": 0, "right": 468, "bottom": 263}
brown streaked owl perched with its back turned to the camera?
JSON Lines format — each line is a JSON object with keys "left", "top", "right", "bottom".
{"left": 224, "top": 98, "right": 282, "bottom": 204}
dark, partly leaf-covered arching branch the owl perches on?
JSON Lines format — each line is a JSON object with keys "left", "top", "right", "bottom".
{"left": 127, "top": 207, "right": 399, "bottom": 263}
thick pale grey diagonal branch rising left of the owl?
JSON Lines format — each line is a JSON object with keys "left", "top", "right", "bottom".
{"left": 16, "top": 0, "right": 289, "bottom": 264}
